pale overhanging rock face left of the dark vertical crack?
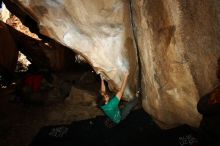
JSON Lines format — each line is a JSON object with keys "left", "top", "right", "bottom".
{"left": 8, "top": 0, "right": 138, "bottom": 100}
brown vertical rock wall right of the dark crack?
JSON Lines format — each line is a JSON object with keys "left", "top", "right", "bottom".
{"left": 132, "top": 0, "right": 220, "bottom": 127}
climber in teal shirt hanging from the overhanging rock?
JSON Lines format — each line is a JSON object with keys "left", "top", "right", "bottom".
{"left": 98, "top": 72, "right": 139, "bottom": 127}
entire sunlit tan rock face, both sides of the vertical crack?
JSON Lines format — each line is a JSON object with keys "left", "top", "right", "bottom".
{"left": 4, "top": 0, "right": 220, "bottom": 128}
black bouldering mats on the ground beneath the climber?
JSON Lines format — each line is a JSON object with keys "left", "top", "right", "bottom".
{"left": 30, "top": 109, "right": 199, "bottom": 146}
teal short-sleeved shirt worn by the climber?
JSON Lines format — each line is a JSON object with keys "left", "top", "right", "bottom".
{"left": 101, "top": 96, "right": 121, "bottom": 124}
